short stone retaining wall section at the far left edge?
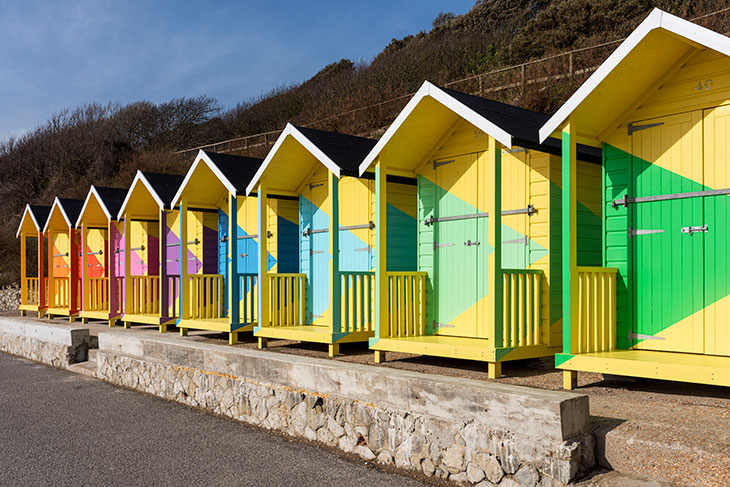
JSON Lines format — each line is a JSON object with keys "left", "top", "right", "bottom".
{"left": 0, "top": 316, "right": 90, "bottom": 368}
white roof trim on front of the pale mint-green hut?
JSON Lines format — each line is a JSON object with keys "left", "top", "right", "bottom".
{"left": 360, "top": 81, "right": 512, "bottom": 176}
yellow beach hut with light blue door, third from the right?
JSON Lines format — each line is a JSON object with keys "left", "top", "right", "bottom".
{"left": 246, "top": 124, "right": 416, "bottom": 356}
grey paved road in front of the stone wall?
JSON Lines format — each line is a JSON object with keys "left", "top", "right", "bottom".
{"left": 0, "top": 353, "right": 422, "bottom": 487}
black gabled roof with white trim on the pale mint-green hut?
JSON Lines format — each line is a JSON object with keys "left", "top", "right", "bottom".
{"left": 360, "top": 81, "right": 601, "bottom": 174}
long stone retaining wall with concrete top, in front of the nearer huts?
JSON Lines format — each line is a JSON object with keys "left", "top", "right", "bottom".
{"left": 97, "top": 332, "right": 594, "bottom": 487}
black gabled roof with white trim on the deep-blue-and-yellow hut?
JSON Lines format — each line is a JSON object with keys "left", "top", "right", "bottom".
{"left": 172, "top": 149, "right": 263, "bottom": 204}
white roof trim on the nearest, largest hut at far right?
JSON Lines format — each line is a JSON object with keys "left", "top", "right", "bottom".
{"left": 540, "top": 8, "right": 730, "bottom": 142}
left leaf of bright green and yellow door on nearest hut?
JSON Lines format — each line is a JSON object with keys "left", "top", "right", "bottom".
{"left": 629, "top": 111, "right": 707, "bottom": 353}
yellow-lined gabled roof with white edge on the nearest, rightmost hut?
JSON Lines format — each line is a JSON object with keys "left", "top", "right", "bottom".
{"left": 540, "top": 8, "right": 730, "bottom": 140}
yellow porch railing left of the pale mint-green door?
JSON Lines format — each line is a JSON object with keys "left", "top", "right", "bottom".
{"left": 386, "top": 272, "right": 426, "bottom": 338}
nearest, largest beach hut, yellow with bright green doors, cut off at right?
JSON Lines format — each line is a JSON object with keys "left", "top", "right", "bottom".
{"left": 540, "top": 9, "right": 730, "bottom": 388}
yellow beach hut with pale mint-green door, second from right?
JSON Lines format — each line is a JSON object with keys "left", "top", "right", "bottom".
{"left": 360, "top": 82, "right": 601, "bottom": 378}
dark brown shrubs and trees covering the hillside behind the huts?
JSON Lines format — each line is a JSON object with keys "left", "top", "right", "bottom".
{"left": 0, "top": 0, "right": 728, "bottom": 284}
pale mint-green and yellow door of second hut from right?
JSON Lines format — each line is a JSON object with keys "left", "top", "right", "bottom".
{"left": 433, "top": 154, "right": 478, "bottom": 337}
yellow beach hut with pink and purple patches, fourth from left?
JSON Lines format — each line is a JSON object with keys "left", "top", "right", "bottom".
{"left": 113, "top": 171, "right": 183, "bottom": 333}
